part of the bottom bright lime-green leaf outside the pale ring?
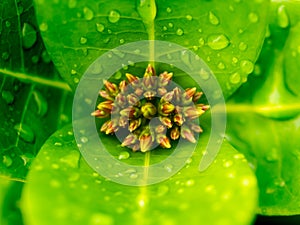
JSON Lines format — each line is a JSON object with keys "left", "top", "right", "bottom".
{"left": 21, "top": 126, "right": 257, "bottom": 225}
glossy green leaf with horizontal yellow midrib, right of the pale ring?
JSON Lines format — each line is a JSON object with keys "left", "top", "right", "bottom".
{"left": 227, "top": 1, "right": 300, "bottom": 215}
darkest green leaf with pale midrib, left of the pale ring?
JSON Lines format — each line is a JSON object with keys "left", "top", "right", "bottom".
{"left": 0, "top": 0, "right": 71, "bottom": 179}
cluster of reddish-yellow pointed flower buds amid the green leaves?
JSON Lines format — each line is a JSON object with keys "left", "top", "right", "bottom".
{"left": 91, "top": 65, "right": 209, "bottom": 152}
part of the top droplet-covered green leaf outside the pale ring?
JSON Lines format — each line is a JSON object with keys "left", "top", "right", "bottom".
{"left": 36, "top": 0, "right": 268, "bottom": 97}
